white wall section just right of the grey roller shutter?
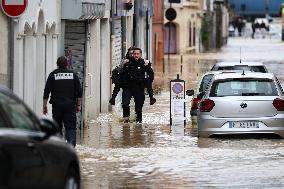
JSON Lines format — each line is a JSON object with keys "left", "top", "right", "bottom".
{"left": 81, "top": 2, "right": 111, "bottom": 121}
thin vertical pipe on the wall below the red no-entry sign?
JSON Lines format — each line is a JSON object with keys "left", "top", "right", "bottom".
{"left": 8, "top": 18, "right": 15, "bottom": 90}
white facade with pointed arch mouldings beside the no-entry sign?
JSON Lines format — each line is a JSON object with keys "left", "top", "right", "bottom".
{"left": 13, "top": 0, "right": 61, "bottom": 115}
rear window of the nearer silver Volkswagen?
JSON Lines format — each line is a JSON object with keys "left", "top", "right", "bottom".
{"left": 210, "top": 78, "right": 278, "bottom": 97}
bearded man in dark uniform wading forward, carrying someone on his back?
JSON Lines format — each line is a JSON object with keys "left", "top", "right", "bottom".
{"left": 122, "top": 48, "right": 146, "bottom": 123}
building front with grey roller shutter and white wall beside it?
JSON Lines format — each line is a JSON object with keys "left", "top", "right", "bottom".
{"left": 60, "top": 0, "right": 111, "bottom": 126}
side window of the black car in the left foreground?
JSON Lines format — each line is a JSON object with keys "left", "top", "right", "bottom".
{"left": 0, "top": 93, "right": 39, "bottom": 130}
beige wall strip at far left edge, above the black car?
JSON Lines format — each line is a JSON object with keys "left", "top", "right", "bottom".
{"left": 0, "top": 11, "right": 9, "bottom": 87}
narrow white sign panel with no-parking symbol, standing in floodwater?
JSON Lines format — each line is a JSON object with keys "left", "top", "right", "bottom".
{"left": 170, "top": 75, "right": 185, "bottom": 125}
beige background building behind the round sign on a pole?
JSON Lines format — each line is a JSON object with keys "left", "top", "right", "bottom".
{"left": 164, "top": 0, "right": 201, "bottom": 55}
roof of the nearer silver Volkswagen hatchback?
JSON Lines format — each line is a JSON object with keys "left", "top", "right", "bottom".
{"left": 214, "top": 72, "right": 274, "bottom": 80}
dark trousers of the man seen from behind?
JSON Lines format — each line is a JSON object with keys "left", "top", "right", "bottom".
{"left": 52, "top": 98, "right": 76, "bottom": 146}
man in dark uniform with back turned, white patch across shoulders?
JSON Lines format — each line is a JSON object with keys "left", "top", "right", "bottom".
{"left": 43, "top": 56, "right": 82, "bottom": 147}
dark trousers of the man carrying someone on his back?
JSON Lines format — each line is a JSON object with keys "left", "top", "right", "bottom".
{"left": 122, "top": 85, "right": 145, "bottom": 122}
